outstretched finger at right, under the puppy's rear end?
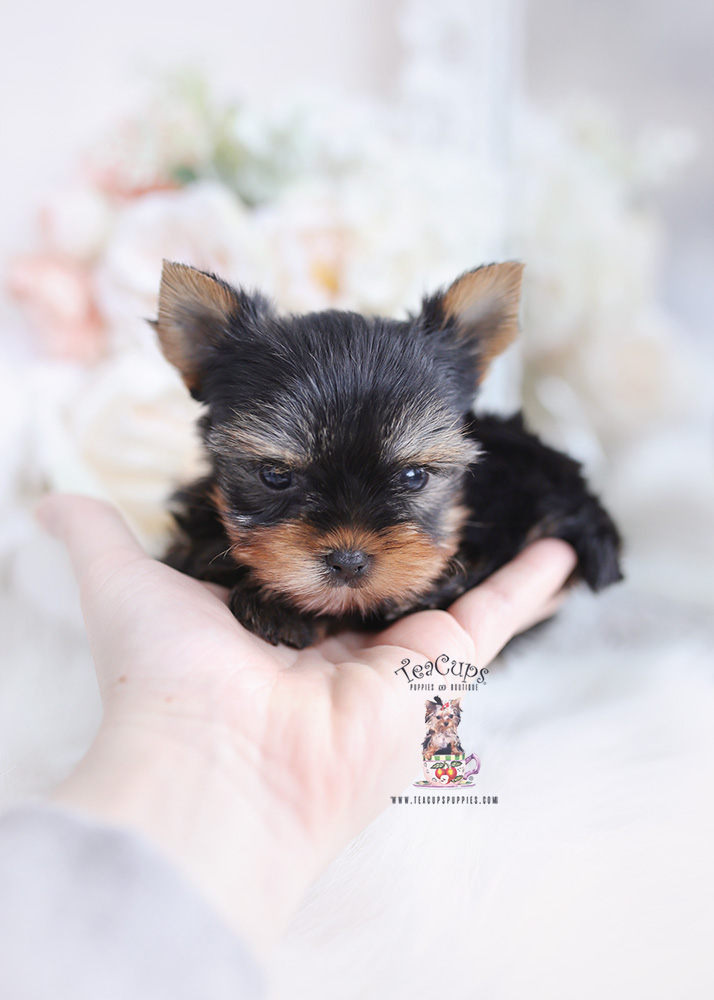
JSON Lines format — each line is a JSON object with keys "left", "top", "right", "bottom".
{"left": 449, "top": 538, "right": 577, "bottom": 663}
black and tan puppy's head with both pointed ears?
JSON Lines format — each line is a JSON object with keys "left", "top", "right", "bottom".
{"left": 155, "top": 262, "right": 522, "bottom": 615}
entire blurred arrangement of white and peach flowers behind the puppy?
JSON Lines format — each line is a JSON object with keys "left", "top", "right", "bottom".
{"left": 0, "top": 78, "right": 678, "bottom": 572}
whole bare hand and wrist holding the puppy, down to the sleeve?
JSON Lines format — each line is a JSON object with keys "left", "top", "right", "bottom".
{"left": 38, "top": 496, "right": 575, "bottom": 952}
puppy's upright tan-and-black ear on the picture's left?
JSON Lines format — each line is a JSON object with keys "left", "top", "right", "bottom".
{"left": 150, "top": 260, "right": 264, "bottom": 399}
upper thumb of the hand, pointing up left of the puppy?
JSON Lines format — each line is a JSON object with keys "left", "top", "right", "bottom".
{"left": 35, "top": 494, "right": 148, "bottom": 584}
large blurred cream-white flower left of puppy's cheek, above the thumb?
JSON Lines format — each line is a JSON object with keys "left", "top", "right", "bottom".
{"left": 25, "top": 349, "right": 202, "bottom": 552}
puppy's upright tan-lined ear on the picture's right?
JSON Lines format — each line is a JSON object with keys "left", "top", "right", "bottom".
{"left": 422, "top": 261, "right": 524, "bottom": 381}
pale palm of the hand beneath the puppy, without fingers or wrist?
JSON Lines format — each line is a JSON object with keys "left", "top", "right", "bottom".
{"left": 80, "top": 546, "right": 471, "bottom": 837}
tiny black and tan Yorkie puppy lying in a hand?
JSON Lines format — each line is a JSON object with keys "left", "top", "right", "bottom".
{"left": 154, "top": 262, "right": 620, "bottom": 649}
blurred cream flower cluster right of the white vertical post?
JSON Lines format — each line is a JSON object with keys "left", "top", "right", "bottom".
{"left": 515, "top": 104, "right": 687, "bottom": 465}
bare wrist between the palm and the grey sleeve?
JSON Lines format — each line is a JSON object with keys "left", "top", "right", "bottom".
{"left": 52, "top": 721, "right": 322, "bottom": 954}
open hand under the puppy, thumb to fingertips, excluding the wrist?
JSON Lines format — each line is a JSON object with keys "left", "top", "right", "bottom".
{"left": 47, "top": 498, "right": 575, "bottom": 843}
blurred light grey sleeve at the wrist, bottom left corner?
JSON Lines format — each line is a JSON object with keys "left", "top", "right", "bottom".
{"left": 0, "top": 805, "right": 263, "bottom": 1000}
